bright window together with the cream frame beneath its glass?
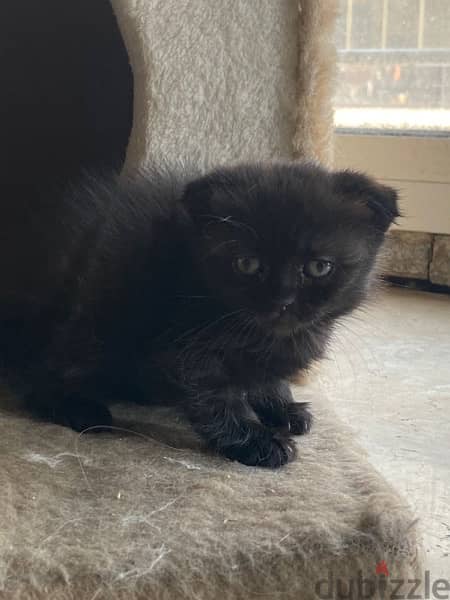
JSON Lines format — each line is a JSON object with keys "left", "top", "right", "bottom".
{"left": 335, "top": 0, "right": 450, "bottom": 234}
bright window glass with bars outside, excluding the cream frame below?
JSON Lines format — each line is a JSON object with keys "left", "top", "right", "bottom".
{"left": 336, "top": 0, "right": 450, "bottom": 131}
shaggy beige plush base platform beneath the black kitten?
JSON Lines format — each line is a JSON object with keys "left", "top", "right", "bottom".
{"left": 0, "top": 389, "right": 420, "bottom": 600}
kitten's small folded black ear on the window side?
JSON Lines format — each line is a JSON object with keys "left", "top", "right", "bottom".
{"left": 332, "top": 171, "right": 400, "bottom": 233}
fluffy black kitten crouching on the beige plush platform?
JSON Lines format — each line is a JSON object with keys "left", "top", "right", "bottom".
{"left": 0, "top": 163, "right": 398, "bottom": 467}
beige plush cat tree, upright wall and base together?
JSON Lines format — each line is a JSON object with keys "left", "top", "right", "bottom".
{"left": 0, "top": 0, "right": 422, "bottom": 600}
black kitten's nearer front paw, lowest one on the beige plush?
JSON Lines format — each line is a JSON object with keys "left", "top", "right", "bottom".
{"left": 222, "top": 431, "right": 296, "bottom": 469}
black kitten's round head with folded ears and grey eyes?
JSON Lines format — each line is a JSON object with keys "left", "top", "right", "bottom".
{"left": 183, "top": 163, "right": 399, "bottom": 336}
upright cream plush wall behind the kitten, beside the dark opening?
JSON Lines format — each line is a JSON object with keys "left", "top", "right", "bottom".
{"left": 112, "top": 0, "right": 337, "bottom": 168}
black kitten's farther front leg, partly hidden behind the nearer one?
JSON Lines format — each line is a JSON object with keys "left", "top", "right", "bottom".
{"left": 249, "top": 381, "right": 312, "bottom": 435}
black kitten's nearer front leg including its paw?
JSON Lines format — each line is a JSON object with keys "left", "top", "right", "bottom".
{"left": 185, "top": 388, "right": 295, "bottom": 468}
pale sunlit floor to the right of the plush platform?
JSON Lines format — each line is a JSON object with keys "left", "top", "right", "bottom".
{"left": 313, "top": 289, "right": 450, "bottom": 578}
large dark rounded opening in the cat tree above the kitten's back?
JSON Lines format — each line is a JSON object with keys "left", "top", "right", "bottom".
{"left": 0, "top": 0, "right": 133, "bottom": 194}
